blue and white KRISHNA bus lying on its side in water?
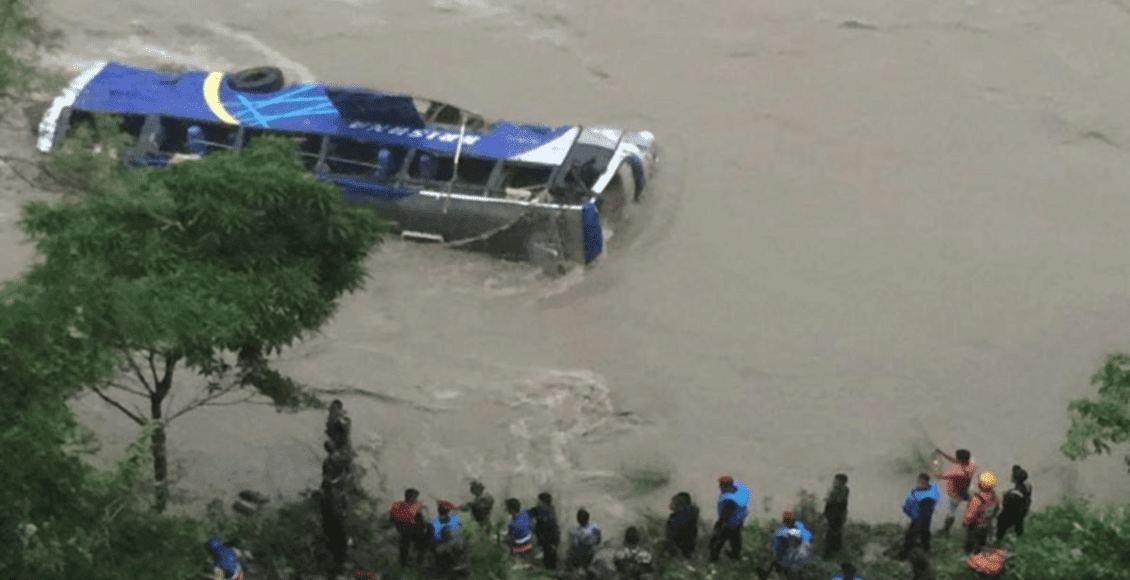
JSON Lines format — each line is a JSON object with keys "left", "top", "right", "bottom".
{"left": 37, "top": 62, "right": 657, "bottom": 267}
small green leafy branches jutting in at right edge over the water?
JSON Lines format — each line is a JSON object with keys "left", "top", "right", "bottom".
{"left": 1060, "top": 353, "right": 1130, "bottom": 466}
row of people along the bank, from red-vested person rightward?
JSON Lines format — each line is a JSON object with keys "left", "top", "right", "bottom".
{"left": 390, "top": 449, "right": 1032, "bottom": 580}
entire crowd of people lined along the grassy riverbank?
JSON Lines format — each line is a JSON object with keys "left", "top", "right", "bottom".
{"left": 206, "top": 400, "right": 1032, "bottom": 580}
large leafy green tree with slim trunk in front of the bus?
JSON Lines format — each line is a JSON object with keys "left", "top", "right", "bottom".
{"left": 20, "top": 132, "right": 385, "bottom": 511}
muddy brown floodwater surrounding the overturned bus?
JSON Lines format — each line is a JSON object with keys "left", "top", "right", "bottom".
{"left": 30, "top": 0, "right": 1130, "bottom": 526}
